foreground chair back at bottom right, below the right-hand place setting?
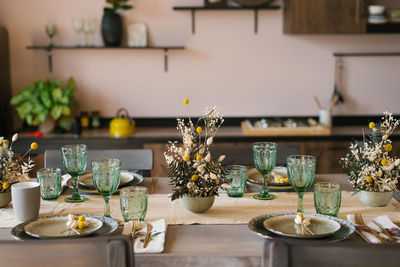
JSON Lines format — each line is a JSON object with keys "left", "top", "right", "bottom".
{"left": 262, "top": 240, "right": 400, "bottom": 267}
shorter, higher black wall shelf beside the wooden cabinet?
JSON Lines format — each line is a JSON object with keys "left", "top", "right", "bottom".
{"left": 173, "top": 5, "right": 281, "bottom": 34}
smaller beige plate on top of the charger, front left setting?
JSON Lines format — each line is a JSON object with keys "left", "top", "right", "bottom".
{"left": 24, "top": 215, "right": 103, "bottom": 238}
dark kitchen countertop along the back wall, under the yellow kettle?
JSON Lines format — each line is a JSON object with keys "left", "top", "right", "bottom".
{"left": 14, "top": 126, "right": 400, "bottom": 153}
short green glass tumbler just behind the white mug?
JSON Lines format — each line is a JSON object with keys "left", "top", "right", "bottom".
{"left": 37, "top": 168, "right": 61, "bottom": 200}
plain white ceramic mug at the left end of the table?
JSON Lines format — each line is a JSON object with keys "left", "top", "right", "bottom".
{"left": 11, "top": 182, "right": 40, "bottom": 221}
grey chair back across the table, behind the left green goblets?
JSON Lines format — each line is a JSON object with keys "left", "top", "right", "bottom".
{"left": 44, "top": 149, "right": 153, "bottom": 176}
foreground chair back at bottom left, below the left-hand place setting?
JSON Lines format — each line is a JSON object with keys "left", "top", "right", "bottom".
{"left": 0, "top": 235, "right": 134, "bottom": 267}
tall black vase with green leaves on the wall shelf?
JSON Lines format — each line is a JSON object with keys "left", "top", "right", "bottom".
{"left": 101, "top": 0, "right": 132, "bottom": 47}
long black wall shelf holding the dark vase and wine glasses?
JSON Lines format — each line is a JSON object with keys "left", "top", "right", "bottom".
{"left": 26, "top": 46, "right": 185, "bottom": 72}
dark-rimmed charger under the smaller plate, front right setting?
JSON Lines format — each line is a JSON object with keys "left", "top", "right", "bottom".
{"left": 248, "top": 212, "right": 355, "bottom": 242}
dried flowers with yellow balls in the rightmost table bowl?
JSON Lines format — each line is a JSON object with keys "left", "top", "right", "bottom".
{"left": 340, "top": 112, "right": 400, "bottom": 207}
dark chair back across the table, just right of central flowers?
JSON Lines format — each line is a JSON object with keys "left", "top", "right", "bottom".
{"left": 210, "top": 144, "right": 300, "bottom": 166}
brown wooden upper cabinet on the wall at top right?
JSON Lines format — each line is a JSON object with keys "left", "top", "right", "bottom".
{"left": 283, "top": 0, "right": 367, "bottom": 34}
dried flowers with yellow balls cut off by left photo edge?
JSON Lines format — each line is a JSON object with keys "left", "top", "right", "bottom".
{"left": 0, "top": 134, "right": 38, "bottom": 196}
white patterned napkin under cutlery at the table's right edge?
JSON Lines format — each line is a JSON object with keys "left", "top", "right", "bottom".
{"left": 347, "top": 214, "right": 400, "bottom": 244}
